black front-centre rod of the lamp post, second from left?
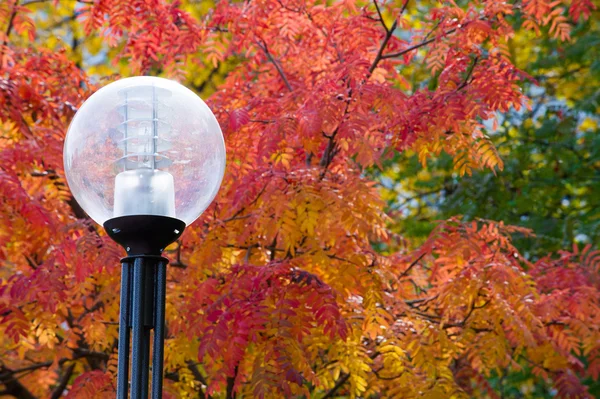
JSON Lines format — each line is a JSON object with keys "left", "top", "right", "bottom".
{"left": 131, "top": 258, "right": 146, "bottom": 399}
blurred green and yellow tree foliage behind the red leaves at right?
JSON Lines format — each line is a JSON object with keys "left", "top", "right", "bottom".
{"left": 374, "top": 13, "right": 600, "bottom": 259}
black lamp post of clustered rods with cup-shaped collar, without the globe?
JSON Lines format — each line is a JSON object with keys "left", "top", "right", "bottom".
{"left": 104, "top": 215, "right": 185, "bottom": 399}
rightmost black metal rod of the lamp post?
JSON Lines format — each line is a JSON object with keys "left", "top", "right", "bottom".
{"left": 152, "top": 260, "right": 167, "bottom": 399}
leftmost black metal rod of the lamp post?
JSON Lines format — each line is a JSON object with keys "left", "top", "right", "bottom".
{"left": 117, "top": 262, "right": 131, "bottom": 399}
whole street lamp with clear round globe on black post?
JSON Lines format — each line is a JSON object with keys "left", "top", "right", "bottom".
{"left": 64, "top": 76, "right": 225, "bottom": 399}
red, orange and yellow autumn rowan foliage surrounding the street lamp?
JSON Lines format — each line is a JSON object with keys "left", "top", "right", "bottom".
{"left": 0, "top": 0, "right": 600, "bottom": 398}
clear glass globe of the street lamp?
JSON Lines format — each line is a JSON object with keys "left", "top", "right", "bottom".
{"left": 64, "top": 76, "right": 225, "bottom": 225}
